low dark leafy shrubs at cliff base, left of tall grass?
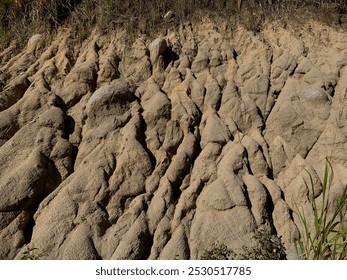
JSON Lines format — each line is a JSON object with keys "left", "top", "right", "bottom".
{"left": 200, "top": 224, "right": 287, "bottom": 260}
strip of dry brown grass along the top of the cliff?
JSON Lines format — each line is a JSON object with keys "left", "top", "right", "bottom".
{"left": 0, "top": 0, "right": 347, "bottom": 49}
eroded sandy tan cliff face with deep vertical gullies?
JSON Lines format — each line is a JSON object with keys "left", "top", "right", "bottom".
{"left": 0, "top": 18, "right": 347, "bottom": 259}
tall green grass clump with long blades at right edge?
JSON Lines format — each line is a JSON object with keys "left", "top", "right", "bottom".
{"left": 294, "top": 161, "right": 347, "bottom": 260}
